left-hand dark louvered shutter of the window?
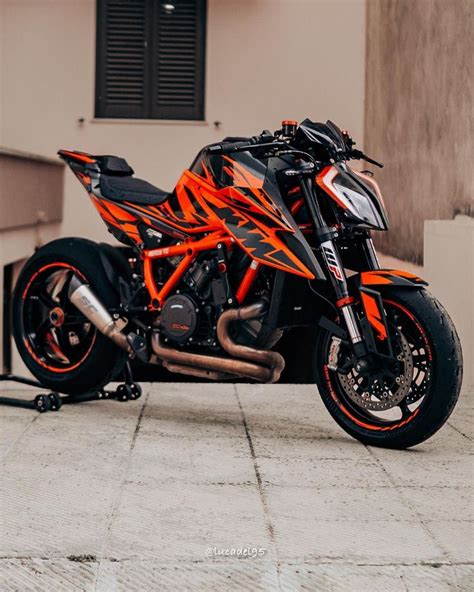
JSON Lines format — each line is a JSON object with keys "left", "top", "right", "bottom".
{"left": 96, "top": 0, "right": 149, "bottom": 118}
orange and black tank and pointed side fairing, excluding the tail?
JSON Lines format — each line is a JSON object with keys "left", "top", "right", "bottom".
{"left": 144, "top": 152, "right": 324, "bottom": 279}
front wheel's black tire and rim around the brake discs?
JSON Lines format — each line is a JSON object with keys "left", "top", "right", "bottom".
{"left": 313, "top": 288, "right": 462, "bottom": 449}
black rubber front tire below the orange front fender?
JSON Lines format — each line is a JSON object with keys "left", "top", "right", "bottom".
{"left": 313, "top": 289, "right": 462, "bottom": 449}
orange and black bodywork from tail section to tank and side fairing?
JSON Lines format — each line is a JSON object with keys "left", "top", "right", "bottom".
{"left": 59, "top": 147, "right": 324, "bottom": 279}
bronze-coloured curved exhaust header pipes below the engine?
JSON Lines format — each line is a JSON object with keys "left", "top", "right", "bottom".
{"left": 151, "top": 302, "right": 285, "bottom": 382}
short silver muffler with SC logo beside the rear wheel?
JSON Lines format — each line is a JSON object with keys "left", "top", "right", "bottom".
{"left": 68, "top": 275, "right": 132, "bottom": 353}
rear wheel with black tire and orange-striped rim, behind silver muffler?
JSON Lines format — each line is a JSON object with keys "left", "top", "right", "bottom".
{"left": 13, "top": 238, "right": 127, "bottom": 395}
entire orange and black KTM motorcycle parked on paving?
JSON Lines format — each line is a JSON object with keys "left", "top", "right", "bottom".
{"left": 13, "top": 119, "right": 462, "bottom": 448}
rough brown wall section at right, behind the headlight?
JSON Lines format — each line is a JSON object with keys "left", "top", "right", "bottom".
{"left": 365, "top": 0, "right": 474, "bottom": 262}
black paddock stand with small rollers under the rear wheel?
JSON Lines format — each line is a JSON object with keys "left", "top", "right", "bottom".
{"left": 0, "top": 362, "right": 142, "bottom": 413}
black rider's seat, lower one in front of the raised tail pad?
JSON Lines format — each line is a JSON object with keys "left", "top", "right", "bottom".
{"left": 100, "top": 174, "right": 170, "bottom": 206}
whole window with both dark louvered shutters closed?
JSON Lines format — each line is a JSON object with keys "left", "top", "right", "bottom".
{"left": 95, "top": 0, "right": 206, "bottom": 119}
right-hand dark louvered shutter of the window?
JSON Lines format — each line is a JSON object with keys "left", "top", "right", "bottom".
{"left": 152, "top": 0, "right": 206, "bottom": 119}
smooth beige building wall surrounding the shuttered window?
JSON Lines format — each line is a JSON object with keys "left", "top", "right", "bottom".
{"left": 0, "top": 0, "right": 365, "bottom": 240}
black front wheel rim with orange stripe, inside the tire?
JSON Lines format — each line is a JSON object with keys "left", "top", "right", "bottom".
{"left": 323, "top": 300, "right": 433, "bottom": 431}
